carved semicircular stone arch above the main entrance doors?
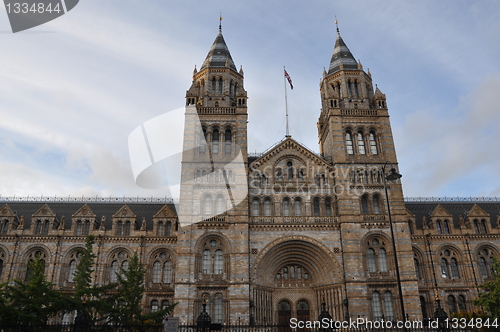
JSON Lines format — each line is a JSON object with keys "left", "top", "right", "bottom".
{"left": 251, "top": 235, "right": 342, "bottom": 286}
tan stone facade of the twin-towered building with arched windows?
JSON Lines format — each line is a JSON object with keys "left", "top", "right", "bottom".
{"left": 0, "top": 25, "right": 500, "bottom": 324}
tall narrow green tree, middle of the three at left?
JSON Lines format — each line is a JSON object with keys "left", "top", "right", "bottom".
{"left": 73, "top": 235, "right": 117, "bottom": 322}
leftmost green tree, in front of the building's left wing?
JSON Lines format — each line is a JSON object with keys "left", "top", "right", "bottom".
{"left": 2, "top": 257, "right": 72, "bottom": 325}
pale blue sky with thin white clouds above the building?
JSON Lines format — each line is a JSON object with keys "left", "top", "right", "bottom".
{"left": 0, "top": 0, "right": 500, "bottom": 196}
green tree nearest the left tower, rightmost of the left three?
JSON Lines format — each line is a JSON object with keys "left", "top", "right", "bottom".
{"left": 109, "top": 252, "right": 175, "bottom": 325}
